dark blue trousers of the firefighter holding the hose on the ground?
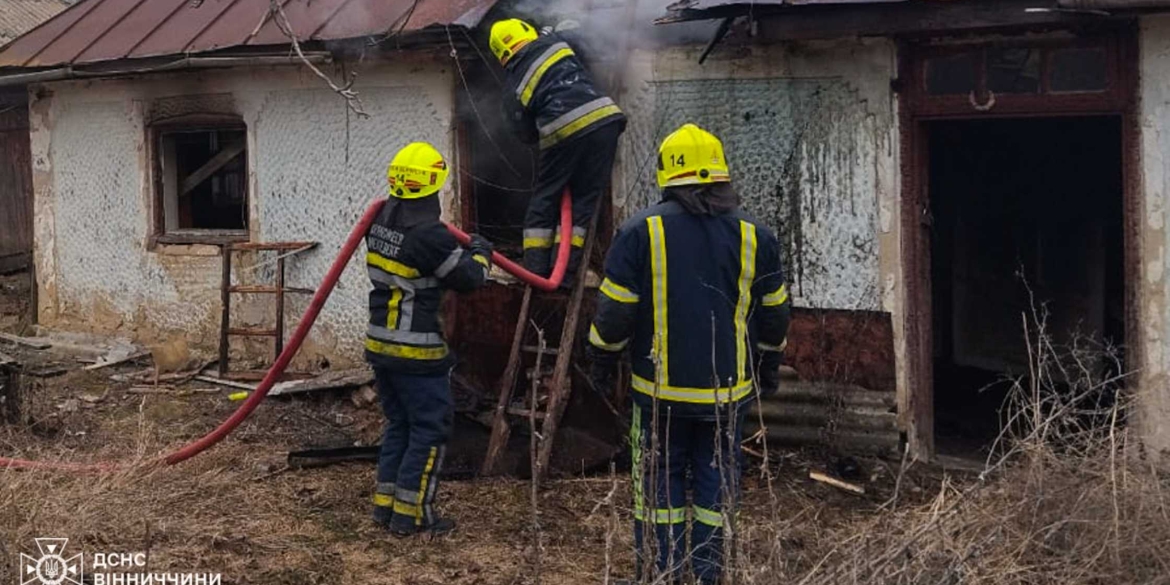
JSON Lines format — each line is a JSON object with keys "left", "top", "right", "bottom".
{"left": 374, "top": 367, "right": 454, "bottom": 530}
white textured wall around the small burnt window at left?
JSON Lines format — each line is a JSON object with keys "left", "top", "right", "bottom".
{"left": 30, "top": 57, "right": 455, "bottom": 362}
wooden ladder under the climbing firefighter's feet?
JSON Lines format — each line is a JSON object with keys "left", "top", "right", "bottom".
{"left": 480, "top": 208, "right": 601, "bottom": 482}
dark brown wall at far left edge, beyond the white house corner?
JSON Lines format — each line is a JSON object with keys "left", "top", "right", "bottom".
{"left": 0, "top": 94, "right": 33, "bottom": 273}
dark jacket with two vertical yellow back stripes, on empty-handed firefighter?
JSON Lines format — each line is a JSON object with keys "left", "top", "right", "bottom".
{"left": 590, "top": 201, "right": 790, "bottom": 415}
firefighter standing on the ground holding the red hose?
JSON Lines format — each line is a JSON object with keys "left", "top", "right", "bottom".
{"left": 365, "top": 143, "right": 491, "bottom": 537}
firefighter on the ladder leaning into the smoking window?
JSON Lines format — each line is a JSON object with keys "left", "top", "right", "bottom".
{"left": 490, "top": 19, "right": 626, "bottom": 284}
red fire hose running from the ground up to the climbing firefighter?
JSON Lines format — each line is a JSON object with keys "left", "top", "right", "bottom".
{"left": 0, "top": 190, "right": 573, "bottom": 473}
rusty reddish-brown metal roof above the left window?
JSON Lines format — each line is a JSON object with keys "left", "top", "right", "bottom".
{"left": 0, "top": 0, "right": 495, "bottom": 68}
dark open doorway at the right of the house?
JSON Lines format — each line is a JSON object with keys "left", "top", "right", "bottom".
{"left": 927, "top": 116, "right": 1126, "bottom": 454}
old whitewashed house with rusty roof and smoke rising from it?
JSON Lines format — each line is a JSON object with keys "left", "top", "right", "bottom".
{"left": 0, "top": 0, "right": 1170, "bottom": 456}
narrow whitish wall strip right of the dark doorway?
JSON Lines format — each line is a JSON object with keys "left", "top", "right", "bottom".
{"left": 1135, "top": 15, "right": 1170, "bottom": 456}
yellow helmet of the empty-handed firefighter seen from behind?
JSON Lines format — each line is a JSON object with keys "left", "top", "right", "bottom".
{"left": 659, "top": 124, "right": 731, "bottom": 188}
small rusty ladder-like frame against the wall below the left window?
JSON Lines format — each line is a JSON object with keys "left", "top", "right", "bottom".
{"left": 219, "top": 242, "right": 317, "bottom": 378}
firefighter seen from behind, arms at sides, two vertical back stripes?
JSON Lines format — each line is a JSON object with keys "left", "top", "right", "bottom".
{"left": 590, "top": 124, "right": 790, "bottom": 584}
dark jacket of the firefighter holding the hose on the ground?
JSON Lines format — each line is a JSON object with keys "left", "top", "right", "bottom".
{"left": 365, "top": 200, "right": 490, "bottom": 374}
